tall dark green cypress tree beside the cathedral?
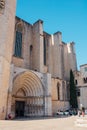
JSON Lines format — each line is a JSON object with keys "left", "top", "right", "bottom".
{"left": 70, "top": 70, "right": 78, "bottom": 108}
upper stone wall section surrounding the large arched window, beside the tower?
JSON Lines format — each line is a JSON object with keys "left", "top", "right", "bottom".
{"left": 12, "top": 17, "right": 33, "bottom": 69}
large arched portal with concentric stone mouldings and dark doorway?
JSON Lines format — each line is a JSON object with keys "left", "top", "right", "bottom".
{"left": 11, "top": 71, "right": 44, "bottom": 116}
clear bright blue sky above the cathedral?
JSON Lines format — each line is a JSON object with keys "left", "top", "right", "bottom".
{"left": 16, "top": 0, "right": 87, "bottom": 68}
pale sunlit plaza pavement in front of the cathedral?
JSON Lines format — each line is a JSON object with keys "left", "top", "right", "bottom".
{"left": 0, "top": 116, "right": 87, "bottom": 130}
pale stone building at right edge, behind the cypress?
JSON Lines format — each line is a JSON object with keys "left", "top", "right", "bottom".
{"left": 74, "top": 64, "right": 87, "bottom": 109}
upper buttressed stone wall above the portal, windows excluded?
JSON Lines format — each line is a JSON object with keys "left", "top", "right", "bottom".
{"left": 13, "top": 17, "right": 77, "bottom": 80}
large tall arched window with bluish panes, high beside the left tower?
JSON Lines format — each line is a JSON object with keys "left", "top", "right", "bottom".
{"left": 14, "top": 24, "right": 22, "bottom": 57}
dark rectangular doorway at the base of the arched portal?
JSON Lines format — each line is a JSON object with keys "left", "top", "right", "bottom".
{"left": 15, "top": 101, "right": 25, "bottom": 117}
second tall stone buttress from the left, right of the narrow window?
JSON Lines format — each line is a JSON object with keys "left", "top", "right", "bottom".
{"left": 52, "top": 32, "right": 62, "bottom": 78}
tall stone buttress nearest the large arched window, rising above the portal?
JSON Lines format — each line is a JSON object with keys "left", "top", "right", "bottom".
{"left": 32, "top": 20, "right": 43, "bottom": 73}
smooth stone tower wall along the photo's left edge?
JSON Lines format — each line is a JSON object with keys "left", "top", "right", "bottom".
{"left": 0, "top": 0, "right": 16, "bottom": 119}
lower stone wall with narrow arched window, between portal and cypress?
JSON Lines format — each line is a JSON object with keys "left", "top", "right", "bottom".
{"left": 52, "top": 78, "right": 70, "bottom": 114}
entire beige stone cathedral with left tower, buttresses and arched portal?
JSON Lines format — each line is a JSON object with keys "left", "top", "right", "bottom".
{"left": 0, "top": 0, "right": 77, "bottom": 119}
